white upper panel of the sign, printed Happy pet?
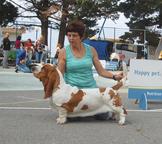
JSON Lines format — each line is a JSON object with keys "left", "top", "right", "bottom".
{"left": 128, "top": 59, "right": 162, "bottom": 89}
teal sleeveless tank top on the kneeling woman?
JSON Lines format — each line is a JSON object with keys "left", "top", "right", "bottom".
{"left": 64, "top": 43, "right": 97, "bottom": 88}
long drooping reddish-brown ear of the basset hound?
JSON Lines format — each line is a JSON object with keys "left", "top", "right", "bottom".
{"left": 44, "top": 68, "right": 60, "bottom": 99}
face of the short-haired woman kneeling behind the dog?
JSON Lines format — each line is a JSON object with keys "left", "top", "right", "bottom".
{"left": 67, "top": 32, "right": 81, "bottom": 45}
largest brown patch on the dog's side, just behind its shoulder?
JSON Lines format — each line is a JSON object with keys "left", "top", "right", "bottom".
{"left": 62, "top": 90, "right": 84, "bottom": 112}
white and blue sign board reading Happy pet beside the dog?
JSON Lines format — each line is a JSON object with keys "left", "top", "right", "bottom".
{"left": 128, "top": 59, "right": 162, "bottom": 110}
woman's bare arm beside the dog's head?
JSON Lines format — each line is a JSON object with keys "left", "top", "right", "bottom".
{"left": 57, "top": 48, "right": 66, "bottom": 74}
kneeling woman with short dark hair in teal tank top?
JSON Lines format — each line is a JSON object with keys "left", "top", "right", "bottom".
{"left": 58, "top": 20, "right": 123, "bottom": 120}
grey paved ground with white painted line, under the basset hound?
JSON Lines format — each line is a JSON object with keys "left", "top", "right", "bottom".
{"left": 0, "top": 67, "right": 162, "bottom": 144}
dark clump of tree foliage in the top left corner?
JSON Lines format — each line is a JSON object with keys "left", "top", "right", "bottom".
{"left": 0, "top": 0, "right": 18, "bottom": 26}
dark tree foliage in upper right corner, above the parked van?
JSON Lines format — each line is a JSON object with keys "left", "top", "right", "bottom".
{"left": 119, "top": 0, "right": 162, "bottom": 46}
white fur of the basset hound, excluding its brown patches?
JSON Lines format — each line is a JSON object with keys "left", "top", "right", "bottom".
{"left": 33, "top": 65, "right": 126, "bottom": 125}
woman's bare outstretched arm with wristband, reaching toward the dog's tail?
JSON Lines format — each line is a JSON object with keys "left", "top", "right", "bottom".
{"left": 92, "top": 48, "right": 123, "bottom": 80}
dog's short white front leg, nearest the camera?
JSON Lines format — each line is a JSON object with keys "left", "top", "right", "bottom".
{"left": 56, "top": 107, "right": 67, "bottom": 124}
